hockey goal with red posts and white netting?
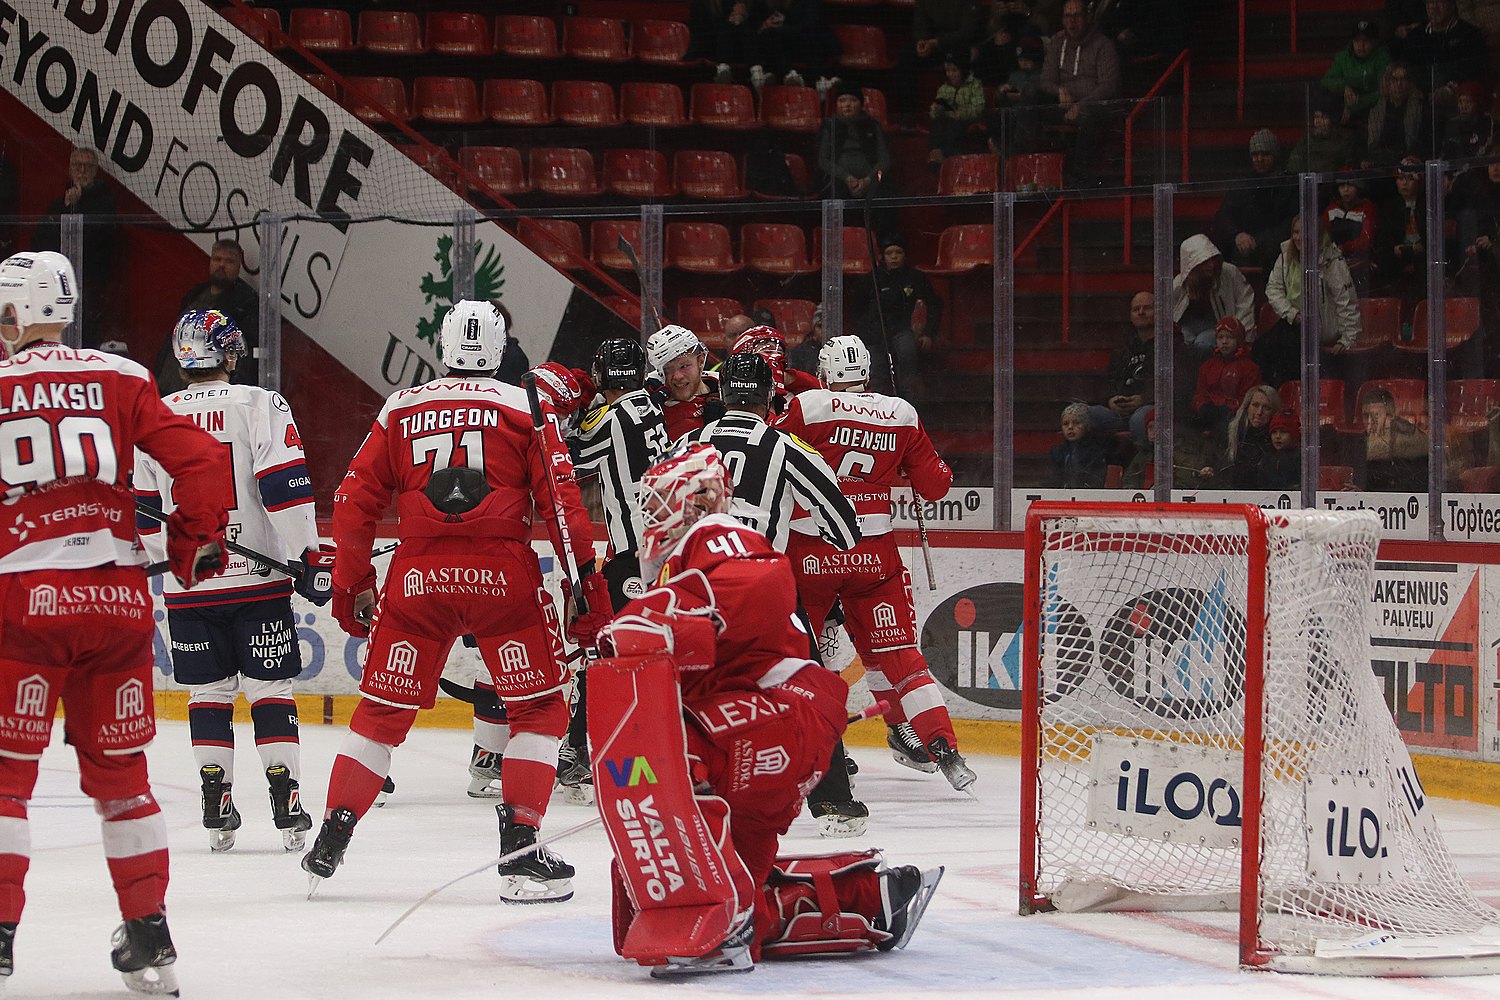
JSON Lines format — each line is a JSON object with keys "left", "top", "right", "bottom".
{"left": 1020, "top": 504, "right": 1500, "bottom": 975}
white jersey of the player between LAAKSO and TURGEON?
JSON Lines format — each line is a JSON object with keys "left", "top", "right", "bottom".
{"left": 135, "top": 382, "right": 318, "bottom": 607}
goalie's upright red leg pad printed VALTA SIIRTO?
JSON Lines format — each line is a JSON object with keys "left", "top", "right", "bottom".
{"left": 588, "top": 657, "right": 755, "bottom": 966}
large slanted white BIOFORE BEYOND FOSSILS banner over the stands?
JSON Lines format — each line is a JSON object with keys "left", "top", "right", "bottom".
{"left": 0, "top": 0, "right": 575, "bottom": 394}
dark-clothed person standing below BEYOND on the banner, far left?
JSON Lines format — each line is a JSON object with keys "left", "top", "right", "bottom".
{"left": 32, "top": 145, "right": 119, "bottom": 348}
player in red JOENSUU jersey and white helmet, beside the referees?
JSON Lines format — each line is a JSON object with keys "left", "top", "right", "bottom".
{"left": 777, "top": 337, "right": 975, "bottom": 792}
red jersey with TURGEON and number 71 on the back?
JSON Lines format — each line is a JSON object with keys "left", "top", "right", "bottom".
{"left": 333, "top": 376, "right": 594, "bottom": 589}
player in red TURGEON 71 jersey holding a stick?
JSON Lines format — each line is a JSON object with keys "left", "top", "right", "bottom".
{"left": 302, "top": 301, "right": 609, "bottom": 903}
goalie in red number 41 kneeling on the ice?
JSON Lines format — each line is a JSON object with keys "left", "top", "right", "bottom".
{"left": 588, "top": 444, "right": 942, "bottom": 978}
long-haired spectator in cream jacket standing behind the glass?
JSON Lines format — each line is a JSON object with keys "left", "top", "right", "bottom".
{"left": 1256, "top": 216, "right": 1361, "bottom": 385}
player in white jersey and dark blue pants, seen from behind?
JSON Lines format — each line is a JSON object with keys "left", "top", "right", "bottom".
{"left": 135, "top": 309, "right": 333, "bottom": 852}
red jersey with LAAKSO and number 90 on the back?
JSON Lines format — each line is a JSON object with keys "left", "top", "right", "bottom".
{"left": 0, "top": 342, "right": 230, "bottom": 573}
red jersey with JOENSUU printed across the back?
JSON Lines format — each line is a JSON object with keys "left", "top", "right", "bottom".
{"left": 776, "top": 388, "right": 953, "bottom": 538}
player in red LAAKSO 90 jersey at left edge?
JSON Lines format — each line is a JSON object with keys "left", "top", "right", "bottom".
{"left": 0, "top": 252, "right": 230, "bottom": 996}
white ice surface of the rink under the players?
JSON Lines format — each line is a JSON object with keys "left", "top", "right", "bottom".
{"left": 20, "top": 723, "right": 1500, "bottom": 1000}
